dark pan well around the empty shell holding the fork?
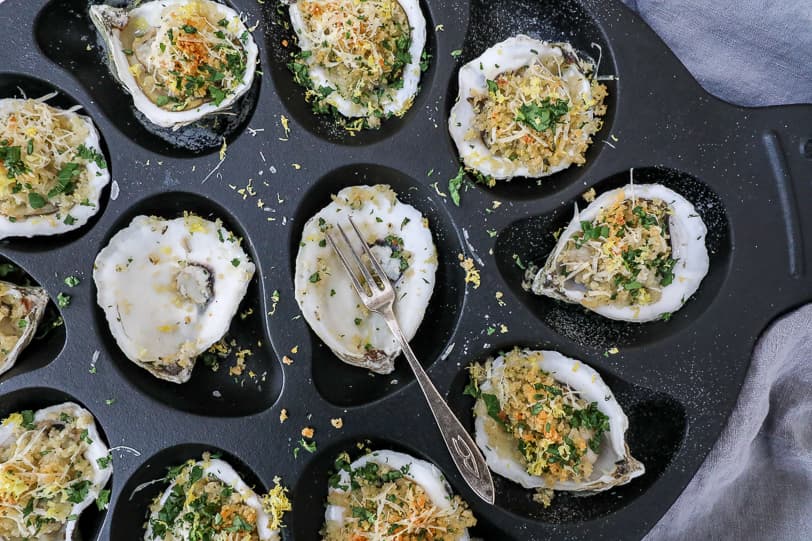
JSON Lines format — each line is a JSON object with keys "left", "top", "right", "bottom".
{"left": 290, "top": 164, "right": 465, "bottom": 406}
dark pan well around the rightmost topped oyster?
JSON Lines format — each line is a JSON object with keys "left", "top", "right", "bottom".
{"left": 494, "top": 167, "right": 732, "bottom": 353}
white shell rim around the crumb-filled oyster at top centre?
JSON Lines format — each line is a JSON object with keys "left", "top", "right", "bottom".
{"left": 289, "top": 0, "right": 426, "bottom": 118}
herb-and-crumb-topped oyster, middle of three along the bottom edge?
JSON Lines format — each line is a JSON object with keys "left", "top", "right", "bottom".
{"left": 144, "top": 453, "right": 291, "bottom": 541}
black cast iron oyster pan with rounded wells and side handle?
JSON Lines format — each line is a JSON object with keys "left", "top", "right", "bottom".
{"left": 0, "top": 0, "right": 812, "bottom": 540}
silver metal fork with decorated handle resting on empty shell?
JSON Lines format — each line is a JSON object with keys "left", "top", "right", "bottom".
{"left": 327, "top": 218, "right": 495, "bottom": 504}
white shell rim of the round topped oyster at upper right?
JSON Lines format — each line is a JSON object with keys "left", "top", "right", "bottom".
{"left": 448, "top": 34, "right": 592, "bottom": 179}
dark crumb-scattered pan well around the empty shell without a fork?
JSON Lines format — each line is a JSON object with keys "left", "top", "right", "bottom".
{"left": 94, "top": 192, "right": 282, "bottom": 417}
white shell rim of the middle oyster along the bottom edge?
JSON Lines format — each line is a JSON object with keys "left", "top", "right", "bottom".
{"left": 144, "top": 458, "right": 279, "bottom": 541}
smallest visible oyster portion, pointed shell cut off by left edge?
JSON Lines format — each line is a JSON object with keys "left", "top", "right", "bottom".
{"left": 0, "top": 281, "right": 48, "bottom": 374}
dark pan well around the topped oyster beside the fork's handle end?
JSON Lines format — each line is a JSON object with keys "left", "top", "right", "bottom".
{"left": 447, "top": 344, "right": 687, "bottom": 524}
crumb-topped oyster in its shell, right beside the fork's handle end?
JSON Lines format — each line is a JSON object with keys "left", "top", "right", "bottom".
{"left": 466, "top": 348, "right": 645, "bottom": 503}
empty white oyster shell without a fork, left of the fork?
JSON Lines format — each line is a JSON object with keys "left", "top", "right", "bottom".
{"left": 93, "top": 215, "right": 254, "bottom": 383}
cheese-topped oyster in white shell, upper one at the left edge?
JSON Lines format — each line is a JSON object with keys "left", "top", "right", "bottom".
{"left": 0, "top": 98, "right": 110, "bottom": 239}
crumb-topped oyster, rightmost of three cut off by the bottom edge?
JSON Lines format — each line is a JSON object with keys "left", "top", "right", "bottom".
{"left": 321, "top": 451, "right": 476, "bottom": 541}
